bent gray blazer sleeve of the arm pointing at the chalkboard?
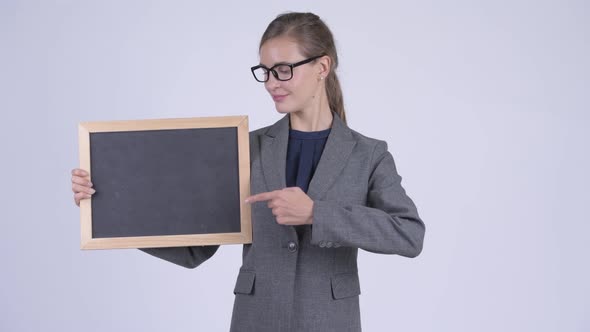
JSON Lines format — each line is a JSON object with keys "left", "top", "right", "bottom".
{"left": 311, "top": 141, "right": 425, "bottom": 257}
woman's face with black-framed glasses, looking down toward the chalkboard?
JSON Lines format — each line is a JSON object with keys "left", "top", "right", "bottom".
{"left": 260, "top": 37, "right": 326, "bottom": 113}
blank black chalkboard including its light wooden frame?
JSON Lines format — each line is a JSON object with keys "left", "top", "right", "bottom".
{"left": 79, "top": 116, "right": 251, "bottom": 249}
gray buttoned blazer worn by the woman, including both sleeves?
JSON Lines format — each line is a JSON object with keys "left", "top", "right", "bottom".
{"left": 142, "top": 113, "right": 424, "bottom": 332}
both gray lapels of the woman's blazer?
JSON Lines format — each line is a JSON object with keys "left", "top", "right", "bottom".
{"left": 261, "top": 112, "right": 356, "bottom": 200}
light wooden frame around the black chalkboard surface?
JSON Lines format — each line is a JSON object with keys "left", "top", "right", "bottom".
{"left": 78, "top": 116, "right": 252, "bottom": 249}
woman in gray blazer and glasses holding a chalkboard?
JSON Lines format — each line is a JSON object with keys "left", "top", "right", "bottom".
{"left": 72, "top": 13, "right": 424, "bottom": 332}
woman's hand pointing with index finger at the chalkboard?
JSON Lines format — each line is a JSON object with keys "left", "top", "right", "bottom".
{"left": 245, "top": 187, "right": 313, "bottom": 226}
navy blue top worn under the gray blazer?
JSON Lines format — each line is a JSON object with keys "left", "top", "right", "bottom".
{"left": 285, "top": 128, "right": 331, "bottom": 239}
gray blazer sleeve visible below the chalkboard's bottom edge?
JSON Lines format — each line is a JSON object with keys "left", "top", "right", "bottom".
{"left": 139, "top": 245, "right": 219, "bottom": 269}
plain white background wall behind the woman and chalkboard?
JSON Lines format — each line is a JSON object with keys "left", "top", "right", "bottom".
{"left": 0, "top": 0, "right": 590, "bottom": 332}
